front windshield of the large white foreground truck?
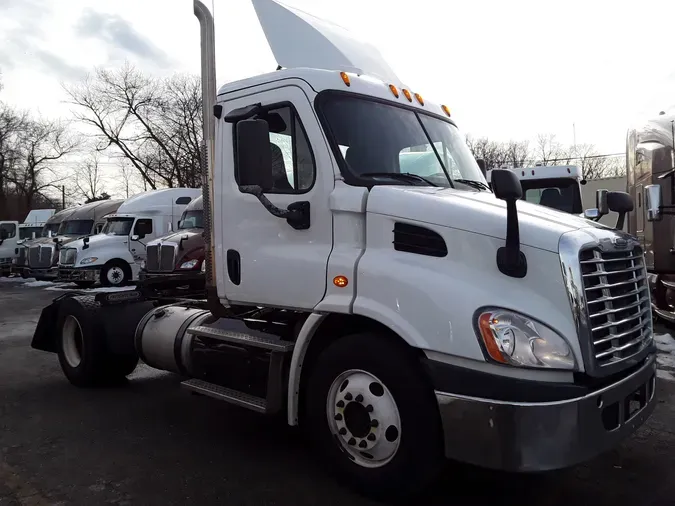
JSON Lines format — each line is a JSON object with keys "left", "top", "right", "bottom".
{"left": 321, "top": 94, "right": 489, "bottom": 191}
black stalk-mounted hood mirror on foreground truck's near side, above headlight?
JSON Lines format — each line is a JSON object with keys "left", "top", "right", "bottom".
{"left": 491, "top": 169, "right": 527, "bottom": 278}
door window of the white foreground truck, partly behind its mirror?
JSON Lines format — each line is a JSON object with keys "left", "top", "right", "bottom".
{"left": 235, "top": 106, "right": 316, "bottom": 194}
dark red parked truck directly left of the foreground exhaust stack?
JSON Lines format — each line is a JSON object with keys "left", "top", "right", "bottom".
{"left": 139, "top": 195, "right": 206, "bottom": 296}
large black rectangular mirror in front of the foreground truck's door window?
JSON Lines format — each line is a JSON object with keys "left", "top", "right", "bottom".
{"left": 236, "top": 119, "right": 274, "bottom": 192}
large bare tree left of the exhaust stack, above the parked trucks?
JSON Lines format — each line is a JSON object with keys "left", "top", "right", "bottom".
{"left": 65, "top": 64, "right": 202, "bottom": 189}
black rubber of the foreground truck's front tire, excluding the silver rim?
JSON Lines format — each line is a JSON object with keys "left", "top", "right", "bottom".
{"left": 302, "top": 333, "right": 444, "bottom": 499}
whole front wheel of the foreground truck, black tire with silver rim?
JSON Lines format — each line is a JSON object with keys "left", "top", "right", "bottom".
{"left": 305, "top": 333, "right": 443, "bottom": 499}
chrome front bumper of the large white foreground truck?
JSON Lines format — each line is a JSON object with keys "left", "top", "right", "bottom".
{"left": 436, "top": 355, "right": 656, "bottom": 472}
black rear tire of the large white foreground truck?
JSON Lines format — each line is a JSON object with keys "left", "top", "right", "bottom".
{"left": 56, "top": 296, "right": 138, "bottom": 388}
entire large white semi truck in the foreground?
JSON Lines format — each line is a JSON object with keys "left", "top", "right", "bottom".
{"left": 32, "top": 0, "right": 656, "bottom": 498}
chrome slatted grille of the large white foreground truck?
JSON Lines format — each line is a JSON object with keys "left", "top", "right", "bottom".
{"left": 580, "top": 248, "right": 652, "bottom": 367}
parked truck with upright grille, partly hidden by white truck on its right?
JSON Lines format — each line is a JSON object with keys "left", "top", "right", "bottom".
{"left": 26, "top": 200, "right": 122, "bottom": 281}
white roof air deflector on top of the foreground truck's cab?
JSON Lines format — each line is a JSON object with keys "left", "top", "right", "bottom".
{"left": 253, "top": 0, "right": 401, "bottom": 84}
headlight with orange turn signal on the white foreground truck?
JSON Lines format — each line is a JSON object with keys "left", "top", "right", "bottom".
{"left": 478, "top": 309, "right": 576, "bottom": 369}
